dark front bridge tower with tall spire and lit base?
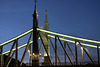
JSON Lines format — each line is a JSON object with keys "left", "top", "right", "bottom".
{"left": 32, "top": 0, "right": 39, "bottom": 66}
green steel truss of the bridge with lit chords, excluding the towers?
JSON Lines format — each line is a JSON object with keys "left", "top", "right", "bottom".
{"left": 0, "top": 28, "right": 100, "bottom": 67}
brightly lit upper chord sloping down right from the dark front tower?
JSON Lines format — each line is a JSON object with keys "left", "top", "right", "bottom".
{"left": 37, "top": 28, "right": 100, "bottom": 44}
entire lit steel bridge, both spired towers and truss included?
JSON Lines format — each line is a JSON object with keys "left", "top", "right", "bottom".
{"left": 0, "top": 0, "right": 100, "bottom": 67}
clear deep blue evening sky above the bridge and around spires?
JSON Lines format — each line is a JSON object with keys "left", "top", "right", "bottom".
{"left": 0, "top": 0, "right": 100, "bottom": 63}
